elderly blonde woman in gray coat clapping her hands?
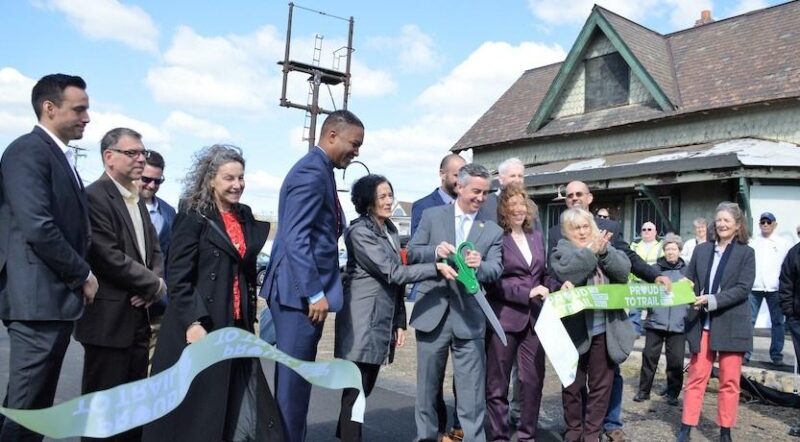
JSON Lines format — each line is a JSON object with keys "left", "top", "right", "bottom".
{"left": 550, "top": 208, "right": 636, "bottom": 442}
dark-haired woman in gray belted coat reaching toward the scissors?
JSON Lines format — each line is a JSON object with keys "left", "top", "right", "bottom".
{"left": 333, "top": 175, "right": 456, "bottom": 441}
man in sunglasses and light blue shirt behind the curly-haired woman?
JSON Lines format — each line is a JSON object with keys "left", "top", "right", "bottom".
{"left": 138, "top": 150, "right": 175, "bottom": 358}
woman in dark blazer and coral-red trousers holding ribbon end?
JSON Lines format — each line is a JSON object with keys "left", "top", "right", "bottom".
{"left": 678, "top": 202, "right": 756, "bottom": 441}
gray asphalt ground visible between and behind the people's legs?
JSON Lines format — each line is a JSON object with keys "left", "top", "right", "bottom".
{"left": 0, "top": 306, "right": 800, "bottom": 442}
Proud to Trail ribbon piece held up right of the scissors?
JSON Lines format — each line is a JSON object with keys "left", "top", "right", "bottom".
{"left": 534, "top": 281, "right": 695, "bottom": 387}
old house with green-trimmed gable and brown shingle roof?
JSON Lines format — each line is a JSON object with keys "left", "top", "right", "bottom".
{"left": 452, "top": 1, "right": 800, "bottom": 240}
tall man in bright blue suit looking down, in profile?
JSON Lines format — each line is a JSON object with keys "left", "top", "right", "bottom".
{"left": 261, "top": 110, "right": 364, "bottom": 441}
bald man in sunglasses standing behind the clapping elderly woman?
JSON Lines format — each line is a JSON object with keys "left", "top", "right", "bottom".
{"left": 548, "top": 181, "right": 672, "bottom": 442}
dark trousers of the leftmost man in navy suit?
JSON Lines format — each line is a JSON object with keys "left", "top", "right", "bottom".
{"left": 0, "top": 321, "right": 74, "bottom": 442}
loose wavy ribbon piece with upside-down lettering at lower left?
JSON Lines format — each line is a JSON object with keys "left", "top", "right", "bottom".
{"left": 0, "top": 327, "right": 366, "bottom": 439}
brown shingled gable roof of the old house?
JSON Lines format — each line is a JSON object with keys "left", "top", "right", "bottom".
{"left": 452, "top": 0, "right": 800, "bottom": 151}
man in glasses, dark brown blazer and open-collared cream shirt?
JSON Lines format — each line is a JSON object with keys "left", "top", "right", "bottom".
{"left": 75, "top": 128, "right": 166, "bottom": 441}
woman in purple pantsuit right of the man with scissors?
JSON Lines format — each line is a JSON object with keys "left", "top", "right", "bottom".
{"left": 486, "top": 186, "right": 557, "bottom": 441}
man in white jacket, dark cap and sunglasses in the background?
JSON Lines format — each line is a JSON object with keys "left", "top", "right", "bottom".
{"left": 744, "top": 212, "right": 791, "bottom": 365}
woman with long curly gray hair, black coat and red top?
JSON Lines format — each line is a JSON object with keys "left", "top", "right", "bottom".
{"left": 143, "top": 145, "right": 283, "bottom": 442}
